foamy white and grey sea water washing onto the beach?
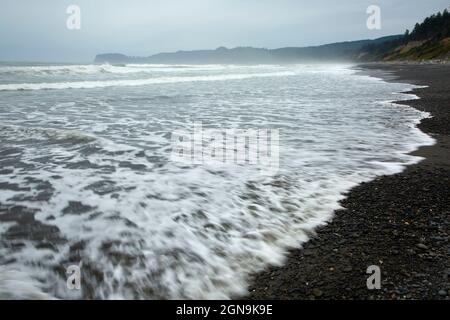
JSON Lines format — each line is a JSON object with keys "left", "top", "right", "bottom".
{"left": 0, "top": 65, "right": 433, "bottom": 299}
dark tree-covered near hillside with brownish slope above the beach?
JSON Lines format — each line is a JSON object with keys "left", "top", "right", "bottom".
{"left": 356, "top": 10, "right": 450, "bottom": 61}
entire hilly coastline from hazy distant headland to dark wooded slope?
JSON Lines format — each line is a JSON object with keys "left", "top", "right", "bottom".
{"left": 95, "top": 10, "right": 450, "bottom": 64}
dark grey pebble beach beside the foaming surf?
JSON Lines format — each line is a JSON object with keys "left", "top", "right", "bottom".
{"left": 244, "top": 63, "right": 450, "bottom": 300}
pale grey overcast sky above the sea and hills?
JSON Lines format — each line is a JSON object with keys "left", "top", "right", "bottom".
{"left": 0, "top": 0, "right": 450, "bottom": 62}
